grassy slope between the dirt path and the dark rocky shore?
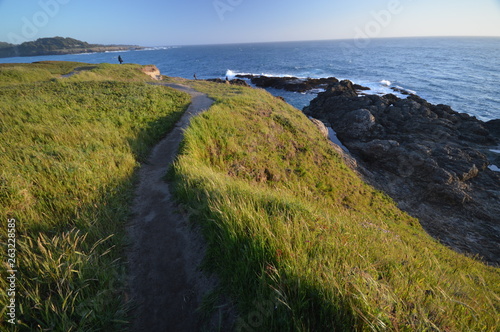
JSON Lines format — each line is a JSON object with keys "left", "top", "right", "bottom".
{"left": 173, "top": 82, "right": 500, "bottom": 331}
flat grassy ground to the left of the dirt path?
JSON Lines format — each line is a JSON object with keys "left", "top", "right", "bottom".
{"left": 0, "top": 63, "right": 189, "bottom": 331}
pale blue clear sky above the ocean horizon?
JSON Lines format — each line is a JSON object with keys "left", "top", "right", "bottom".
{"left": 0, "top": 0, "right": 500, "bottom": 46}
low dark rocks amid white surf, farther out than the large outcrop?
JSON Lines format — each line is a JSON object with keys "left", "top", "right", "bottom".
{"left": 236, "top": 75, "right": 370, "bottom": 93}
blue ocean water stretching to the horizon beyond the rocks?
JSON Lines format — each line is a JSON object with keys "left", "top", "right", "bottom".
{"left": 0, "top": 37, "right": 500, "bottom": 120}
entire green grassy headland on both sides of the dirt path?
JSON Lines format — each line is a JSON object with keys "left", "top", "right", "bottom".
{"left": 0, "top": 63, "right": 500, "bottom": 331}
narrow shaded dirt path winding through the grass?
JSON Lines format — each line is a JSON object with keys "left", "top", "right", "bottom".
{"left": 128, "top": 84, "right": 217, "bottom": 332}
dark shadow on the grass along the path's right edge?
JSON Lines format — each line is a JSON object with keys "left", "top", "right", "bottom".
{"left": 172, "top": 184, "right": 363, "bottom": 332}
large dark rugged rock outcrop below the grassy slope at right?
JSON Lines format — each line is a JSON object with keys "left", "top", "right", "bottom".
{"left": 304, "top": 81, "right": 500, "bottom": 264}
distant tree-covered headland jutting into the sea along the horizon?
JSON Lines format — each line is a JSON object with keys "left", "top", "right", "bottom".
{"left": 0, "top": 37, "right": 143, "bottom": 58}
